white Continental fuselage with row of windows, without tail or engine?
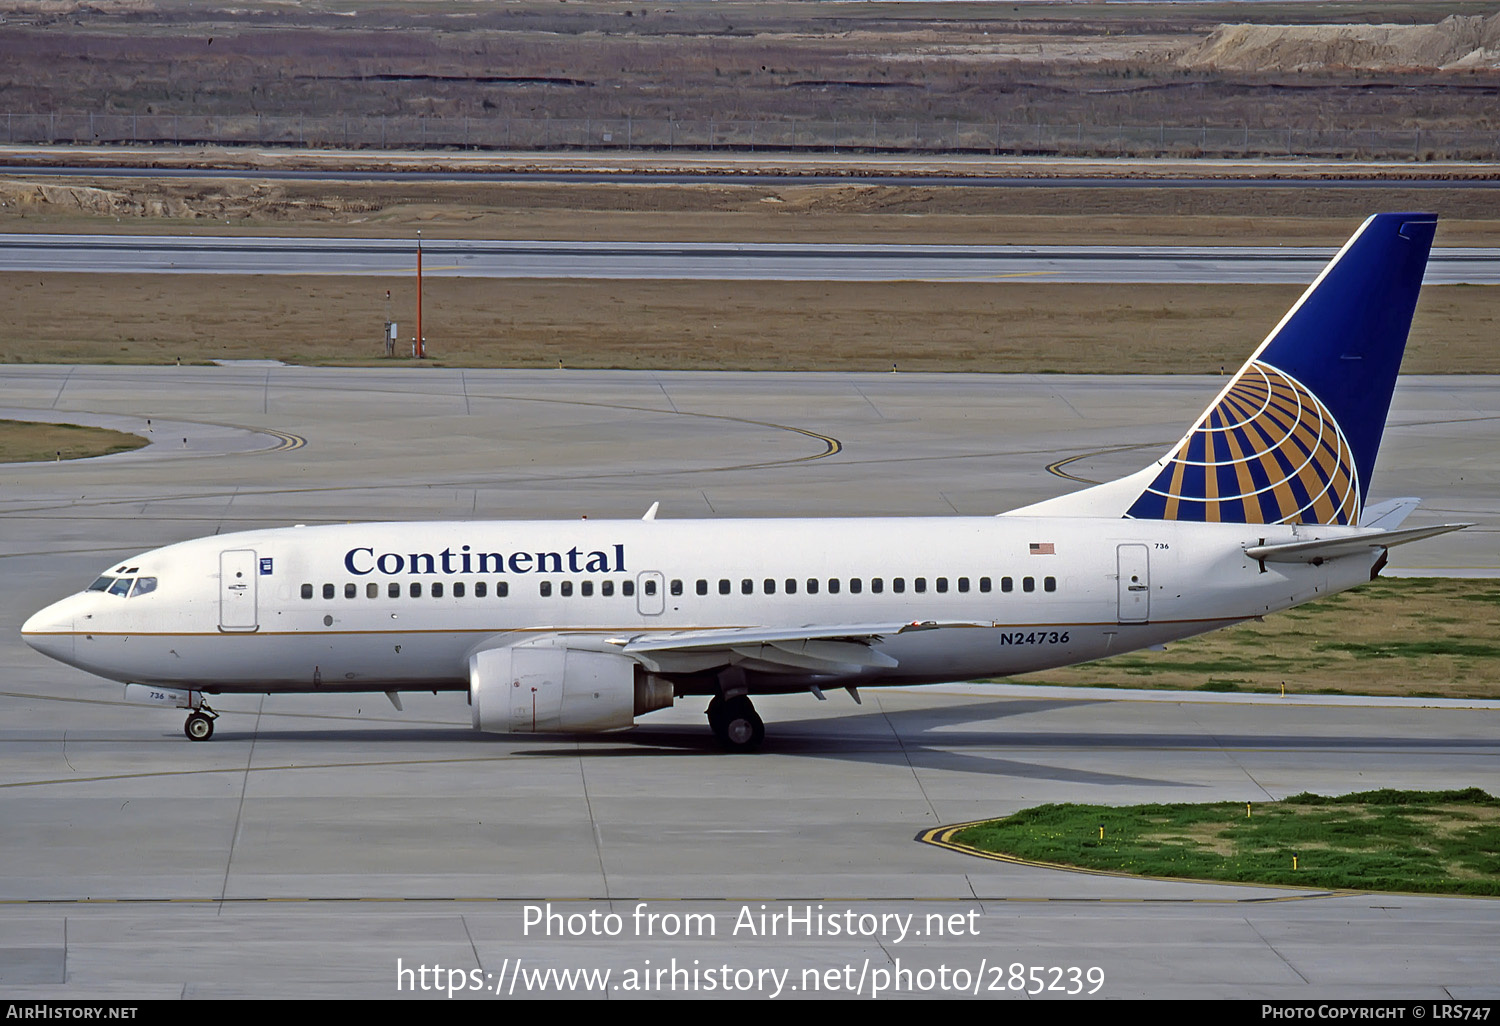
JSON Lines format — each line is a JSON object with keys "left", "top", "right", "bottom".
{"left": 24, "top": 516, "right": 1373, "bottom": 693}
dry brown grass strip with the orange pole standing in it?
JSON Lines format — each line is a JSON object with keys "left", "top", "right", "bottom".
{"left": 0, "top": 272, "right": 1500, "bottom": 375}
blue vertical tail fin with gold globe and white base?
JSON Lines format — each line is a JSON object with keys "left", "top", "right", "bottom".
{"left": 1016, "top": 213, "right": 1437, "bottom": 524}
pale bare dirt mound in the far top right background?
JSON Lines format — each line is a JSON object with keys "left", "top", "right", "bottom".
{"left": 1178, "top": 14, "right": 1500, "bottom": 72}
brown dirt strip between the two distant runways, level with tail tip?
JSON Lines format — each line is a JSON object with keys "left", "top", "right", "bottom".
{"left": 0, "top": 174, "right": 1500, "bottom": 246}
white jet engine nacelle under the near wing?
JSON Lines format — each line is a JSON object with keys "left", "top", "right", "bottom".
{"left": 470, "top": 639, "right": 660, "bottom": 734}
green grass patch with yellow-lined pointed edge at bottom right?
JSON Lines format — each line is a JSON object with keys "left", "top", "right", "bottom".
{"left": 953, "top": 788, "right": 1500, "bottom": 894}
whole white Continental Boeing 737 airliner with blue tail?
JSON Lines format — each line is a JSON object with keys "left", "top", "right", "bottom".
{"left": 23, "top": 213, "right": 1467, "bottom": 750}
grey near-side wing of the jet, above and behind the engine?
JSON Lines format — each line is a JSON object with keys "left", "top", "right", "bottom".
{"left": 612, "top": 621, "right": 992, "bottom": 674}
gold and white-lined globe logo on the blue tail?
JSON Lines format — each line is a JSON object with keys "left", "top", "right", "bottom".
{"left": 1127, "top": 360, "right": 1359, "bottom": 524}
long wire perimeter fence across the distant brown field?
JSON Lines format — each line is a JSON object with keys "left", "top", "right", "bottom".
{"left": 0, "top": 113, "right": 1500, "bottom": 161}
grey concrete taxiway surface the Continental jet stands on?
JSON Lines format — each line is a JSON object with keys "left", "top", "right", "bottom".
{"left": 0, "top": 366, "right": 1500, "bottom": 999}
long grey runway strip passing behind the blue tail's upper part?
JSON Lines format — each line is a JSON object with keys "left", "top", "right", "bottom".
{"left": 0, "top": 234, "right": 1500, "bottom": 285}
